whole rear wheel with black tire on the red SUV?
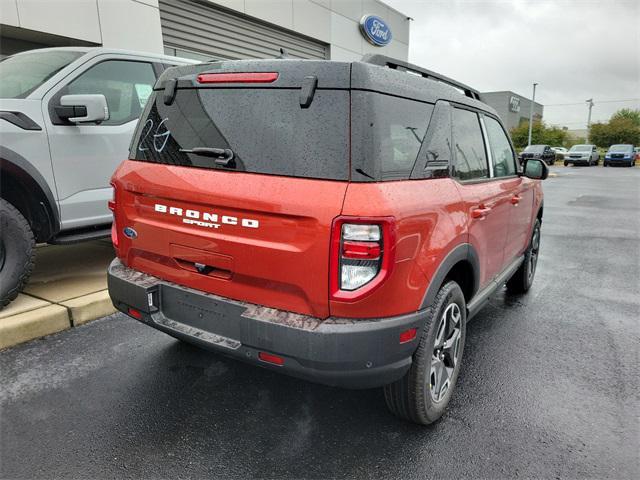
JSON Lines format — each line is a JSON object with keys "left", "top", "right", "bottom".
{"left": 384, "top": 281, "right": 467, "bottom": 425}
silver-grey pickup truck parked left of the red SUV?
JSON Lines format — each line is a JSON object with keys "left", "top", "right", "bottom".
{"left": 0, "top": 47, "right": 197, "bottom": 308}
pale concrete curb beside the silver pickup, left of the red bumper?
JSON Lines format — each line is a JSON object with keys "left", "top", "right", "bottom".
{"left": 0, "top": 290, "right": 116, "bottom": 350}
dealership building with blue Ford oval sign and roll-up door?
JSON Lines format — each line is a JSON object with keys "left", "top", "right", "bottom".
{"left": 0, "top": 0, "right": 410, "bottom": 61}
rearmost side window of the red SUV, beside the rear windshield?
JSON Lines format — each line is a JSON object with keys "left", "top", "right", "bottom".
{"left": 351, "top": 91, "right": 433, "bottom": 181}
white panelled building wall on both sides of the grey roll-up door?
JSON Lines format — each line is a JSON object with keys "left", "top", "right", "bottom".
{"left": 0, "top": 0, "right": 409, "bottom": 61}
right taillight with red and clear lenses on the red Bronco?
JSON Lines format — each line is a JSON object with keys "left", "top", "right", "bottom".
{"left": 329, "top": 217, "right": 395, "bottom": 301}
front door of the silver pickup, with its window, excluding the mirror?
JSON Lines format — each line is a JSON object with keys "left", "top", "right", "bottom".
{"left": 42, "top": 55, "right": 158, "bottom": 230}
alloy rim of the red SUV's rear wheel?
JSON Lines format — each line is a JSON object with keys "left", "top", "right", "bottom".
{"left": 429, "top": 303, "right": 462, "bottom": 403}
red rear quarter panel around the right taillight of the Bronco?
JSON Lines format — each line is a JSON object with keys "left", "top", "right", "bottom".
{"left": 330, "top": 179, "right": 467, "bottom": 318}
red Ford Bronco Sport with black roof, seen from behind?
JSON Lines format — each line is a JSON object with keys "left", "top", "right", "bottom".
{"left": 108, "top": 56, "right": 548, "bottom": 424}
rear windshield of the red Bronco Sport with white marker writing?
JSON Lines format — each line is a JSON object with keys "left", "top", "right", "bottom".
{"left": 130, "top": 88, "right": 349, "bottom": 180}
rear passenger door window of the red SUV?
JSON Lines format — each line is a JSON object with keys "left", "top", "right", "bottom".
{"left": 453, "top": 108, "right": 489, "bottom": 180}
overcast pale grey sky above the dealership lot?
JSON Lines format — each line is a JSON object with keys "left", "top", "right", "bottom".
{"left": 384, "top": 0, "right": 640, "bottom": 129}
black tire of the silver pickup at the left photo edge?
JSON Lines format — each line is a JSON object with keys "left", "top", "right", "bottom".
{"left": 0, "top": 198, "right": 36, "bottom": 310}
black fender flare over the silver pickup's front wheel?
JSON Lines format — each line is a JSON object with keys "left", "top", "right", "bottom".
{"left": 0, "top": 145, "right": 60, "bottom": 242}
